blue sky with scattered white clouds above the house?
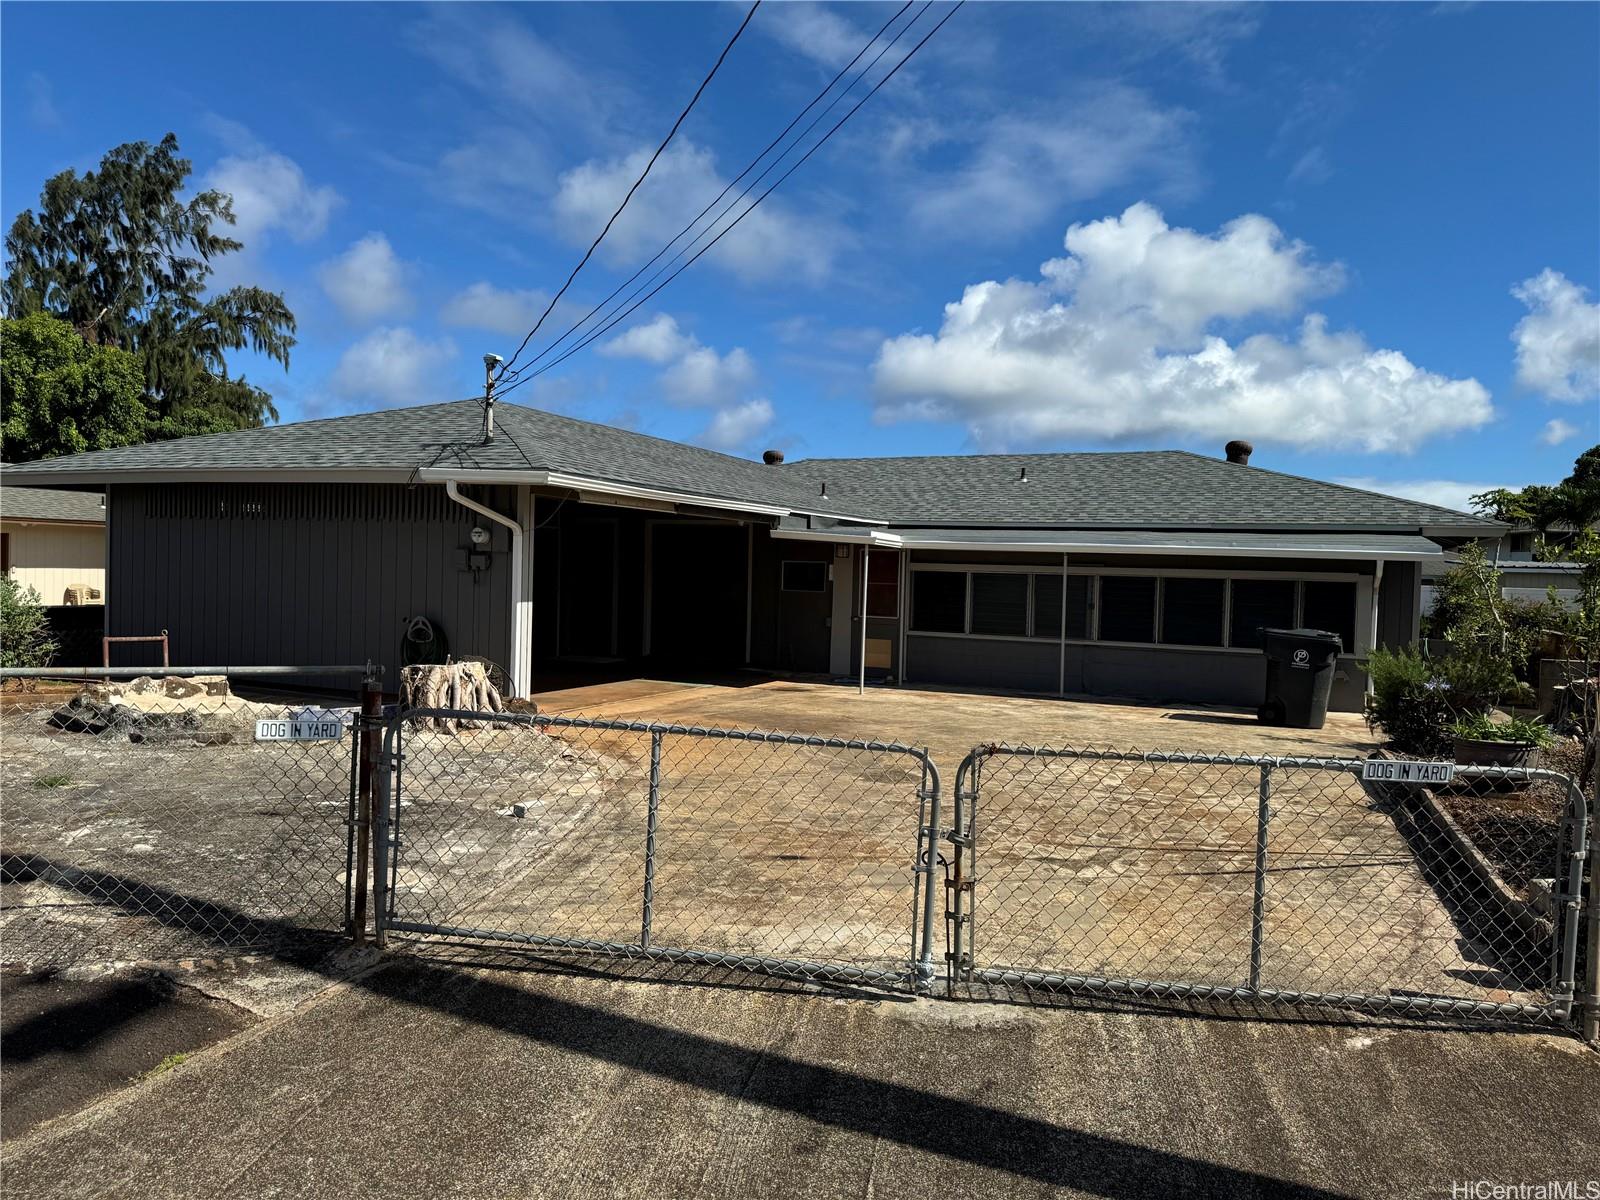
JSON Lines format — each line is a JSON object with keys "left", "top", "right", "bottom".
{"left": 0, "top": 0, "right": 1600, "bottom": 504}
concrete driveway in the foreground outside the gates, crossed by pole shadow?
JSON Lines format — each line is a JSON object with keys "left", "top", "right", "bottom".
{"left": 3, "top": 960, "right": 1600, "bottom": 1200}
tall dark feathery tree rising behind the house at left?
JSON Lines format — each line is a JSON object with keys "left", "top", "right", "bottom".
{"left": 0, "top": 134, "right": 294, "bottom": 451}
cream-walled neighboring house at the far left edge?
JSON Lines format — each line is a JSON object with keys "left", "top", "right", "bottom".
{"left": 0, "top": 483, "right": 106, "bottom": 605}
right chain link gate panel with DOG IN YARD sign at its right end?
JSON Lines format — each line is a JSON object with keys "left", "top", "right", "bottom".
{"left": 946, "top": 746, "right": 1592, "bottom": 1024}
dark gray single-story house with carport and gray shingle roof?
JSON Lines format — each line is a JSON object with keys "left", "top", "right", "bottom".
{"left": 8, "top": 400, "right": 1504, "bottom": 710}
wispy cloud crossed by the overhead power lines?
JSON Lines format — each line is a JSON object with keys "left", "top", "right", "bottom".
{"left": 552, "top": 139, "right": 846, "bottom": 283}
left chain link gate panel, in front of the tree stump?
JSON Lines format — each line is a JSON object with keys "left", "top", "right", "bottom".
{"left": 373, "top": 709, "right": 939, "bottom": 990}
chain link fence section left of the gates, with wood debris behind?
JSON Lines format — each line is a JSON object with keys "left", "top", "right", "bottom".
{"left": 0, "top": 667, "right": 370, "bottom": 970}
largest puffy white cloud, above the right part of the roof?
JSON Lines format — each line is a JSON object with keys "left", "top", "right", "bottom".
{"left": 874, "top": 203, "right": 1493, "bottom": 451}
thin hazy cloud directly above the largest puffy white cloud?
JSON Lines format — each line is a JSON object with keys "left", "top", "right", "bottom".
{"left": 907, "top": 85, "right": 1197, "bottom": 240}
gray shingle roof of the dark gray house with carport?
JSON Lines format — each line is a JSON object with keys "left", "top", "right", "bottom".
{"left": 6, "top": 400, "right": 1499, "bottom": 534}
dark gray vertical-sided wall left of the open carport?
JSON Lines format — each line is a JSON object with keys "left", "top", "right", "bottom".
{"left": 107, "top": 485, "right": 514, "bottom": 688}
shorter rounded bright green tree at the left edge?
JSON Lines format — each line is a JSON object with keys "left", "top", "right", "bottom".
{"left": 0, "top": 312, "right": 149, "bottom": 462}
